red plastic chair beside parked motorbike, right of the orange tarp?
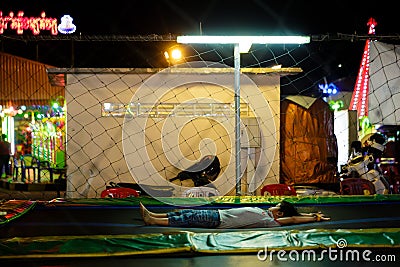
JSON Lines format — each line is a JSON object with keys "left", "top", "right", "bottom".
{"left": 340, "top": 178, "right": 376, "bottom": 195}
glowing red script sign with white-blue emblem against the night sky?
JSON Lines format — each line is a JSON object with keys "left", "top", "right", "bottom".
{"left": 0, "top": 11, "right": 76, "bottom": 35}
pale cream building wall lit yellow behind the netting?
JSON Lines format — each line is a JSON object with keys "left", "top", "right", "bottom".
{"left": 66, "top": 69, "right": 280, "bottom": 198}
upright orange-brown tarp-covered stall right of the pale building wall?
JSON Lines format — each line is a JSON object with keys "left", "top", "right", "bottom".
{"left": 280, "top": 96, "right": 338, "bottom": 185}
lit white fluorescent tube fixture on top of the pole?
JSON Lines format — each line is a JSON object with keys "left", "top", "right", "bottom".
{"left": 176, "top": 35, "right": 310, "bottom": 53}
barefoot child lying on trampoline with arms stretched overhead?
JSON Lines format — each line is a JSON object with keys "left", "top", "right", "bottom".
{"left": 139, "top": 200, "right": 330, "bottom": 229}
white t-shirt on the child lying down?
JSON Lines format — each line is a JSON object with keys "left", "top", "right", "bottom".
{"left": 218, "top": 207, "right": 280, "bottom": 229}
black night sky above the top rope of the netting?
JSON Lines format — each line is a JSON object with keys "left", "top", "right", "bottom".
{"left": 0, "top": 0, "right": 398, "bottom": 35}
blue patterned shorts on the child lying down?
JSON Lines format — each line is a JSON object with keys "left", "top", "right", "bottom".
{"left": 167, "top": 209, "right": 221, "bottom": 228}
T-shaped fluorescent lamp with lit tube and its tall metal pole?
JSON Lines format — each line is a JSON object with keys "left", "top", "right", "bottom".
{"left": 176, "top": 35, "right": 310, "bottom": 195}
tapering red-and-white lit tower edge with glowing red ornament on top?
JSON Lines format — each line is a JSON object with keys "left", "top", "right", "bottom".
{"left": 349, "top": 18, "right": 377, "bottom": 118}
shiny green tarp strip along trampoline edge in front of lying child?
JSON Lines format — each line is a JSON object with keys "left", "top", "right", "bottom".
{"left": 0, "top": 228, "right": 400, "bottom": 259}
